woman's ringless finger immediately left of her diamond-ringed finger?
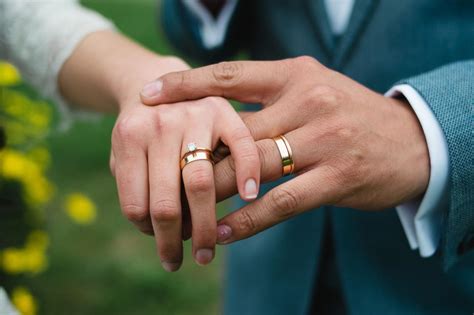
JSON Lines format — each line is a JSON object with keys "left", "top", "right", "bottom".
{"left": 148, "top": 139, "right": 183, "bottom": 272}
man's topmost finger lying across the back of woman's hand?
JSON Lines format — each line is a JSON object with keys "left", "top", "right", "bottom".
{"left": 141, "top": 60, "right": 290, "bottom": 105}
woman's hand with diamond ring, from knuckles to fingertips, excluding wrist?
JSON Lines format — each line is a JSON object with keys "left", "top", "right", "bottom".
{"left": 111, "top": 97, "right": 260, "bottom": 271}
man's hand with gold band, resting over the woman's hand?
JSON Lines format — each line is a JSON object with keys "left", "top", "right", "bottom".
{"left": 142, "top": 57, "right": 430, "bottom": 243}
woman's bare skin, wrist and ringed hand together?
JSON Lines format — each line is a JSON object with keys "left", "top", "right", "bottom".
{"left": 58, "top": 31, "right": 260, "bottom": 271}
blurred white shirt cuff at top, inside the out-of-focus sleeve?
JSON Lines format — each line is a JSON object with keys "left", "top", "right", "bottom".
{"left": 182, "top": 0, "right": 237, "bottom": 49}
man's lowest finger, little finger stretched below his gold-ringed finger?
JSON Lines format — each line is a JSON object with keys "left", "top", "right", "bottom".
{"left": 217, "top": 167, "right": 337, "bottom": 244}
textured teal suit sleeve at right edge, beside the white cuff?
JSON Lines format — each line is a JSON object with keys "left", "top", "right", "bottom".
{"left": 402, "top": 60, "right": 474, "bottom": 269}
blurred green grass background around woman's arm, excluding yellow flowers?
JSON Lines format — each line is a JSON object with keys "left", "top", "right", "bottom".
{"left": 31, "top": 0, "right": 222, "bottom": 315}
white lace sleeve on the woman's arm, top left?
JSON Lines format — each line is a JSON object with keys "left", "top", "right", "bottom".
{"left": 0, "top": 0, "right": 114, "bottom": 126}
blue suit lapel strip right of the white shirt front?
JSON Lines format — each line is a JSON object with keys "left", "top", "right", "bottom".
{"left": 334, "top": 0, "right": 379, "bottom": 70}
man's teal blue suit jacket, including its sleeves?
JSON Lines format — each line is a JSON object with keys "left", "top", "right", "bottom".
{"left": 162, "top": 0, "right": 474, "bottom": 314}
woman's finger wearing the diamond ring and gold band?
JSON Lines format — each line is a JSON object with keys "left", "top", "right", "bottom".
{"left": 182, "top": 139, "right": 216, "bottom": 265}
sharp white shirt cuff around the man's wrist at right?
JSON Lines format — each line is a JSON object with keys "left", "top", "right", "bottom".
{"left": 385, "top": 84, "right": 449, "bottom": 257}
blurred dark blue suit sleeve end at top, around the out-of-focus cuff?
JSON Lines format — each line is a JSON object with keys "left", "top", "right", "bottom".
{"left": 160, "top": 0, "right": 253, "bottom": 64}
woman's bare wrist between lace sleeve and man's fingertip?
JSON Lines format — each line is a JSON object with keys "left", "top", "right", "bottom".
{"left": 58, "top": 31, "right": 188, "bottom": 112}
